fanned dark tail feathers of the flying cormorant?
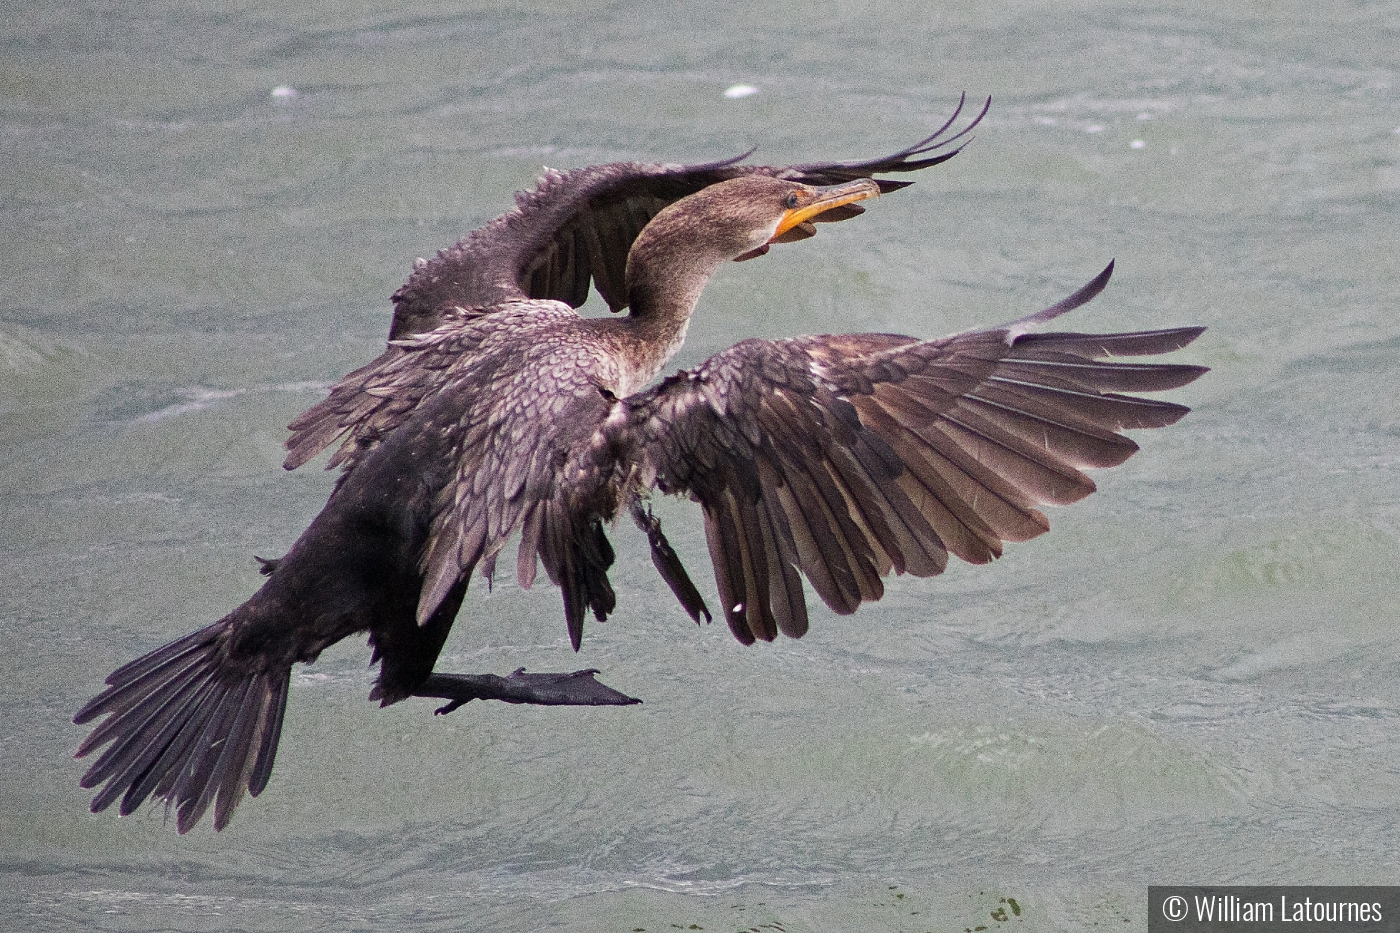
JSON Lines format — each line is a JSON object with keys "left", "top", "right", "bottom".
{"left": 73, "top": 611, "right": 291, "bottom": 834}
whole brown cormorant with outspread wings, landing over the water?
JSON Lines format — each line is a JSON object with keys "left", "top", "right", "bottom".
{"left": 76, "top": 98, "right": 1204, "bottom": 832}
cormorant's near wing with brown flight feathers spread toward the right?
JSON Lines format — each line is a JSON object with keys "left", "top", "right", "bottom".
{"left": 617, "top": 257, "right": 1205, "bottom": 643}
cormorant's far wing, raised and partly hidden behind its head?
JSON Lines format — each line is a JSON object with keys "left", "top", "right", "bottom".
{"left": 389, "top": 98, "right": 991, "bottom": 340}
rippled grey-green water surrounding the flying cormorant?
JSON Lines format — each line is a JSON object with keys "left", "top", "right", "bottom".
{"left": 0, "top": 1, "right": 1400, "bottom": 933}
